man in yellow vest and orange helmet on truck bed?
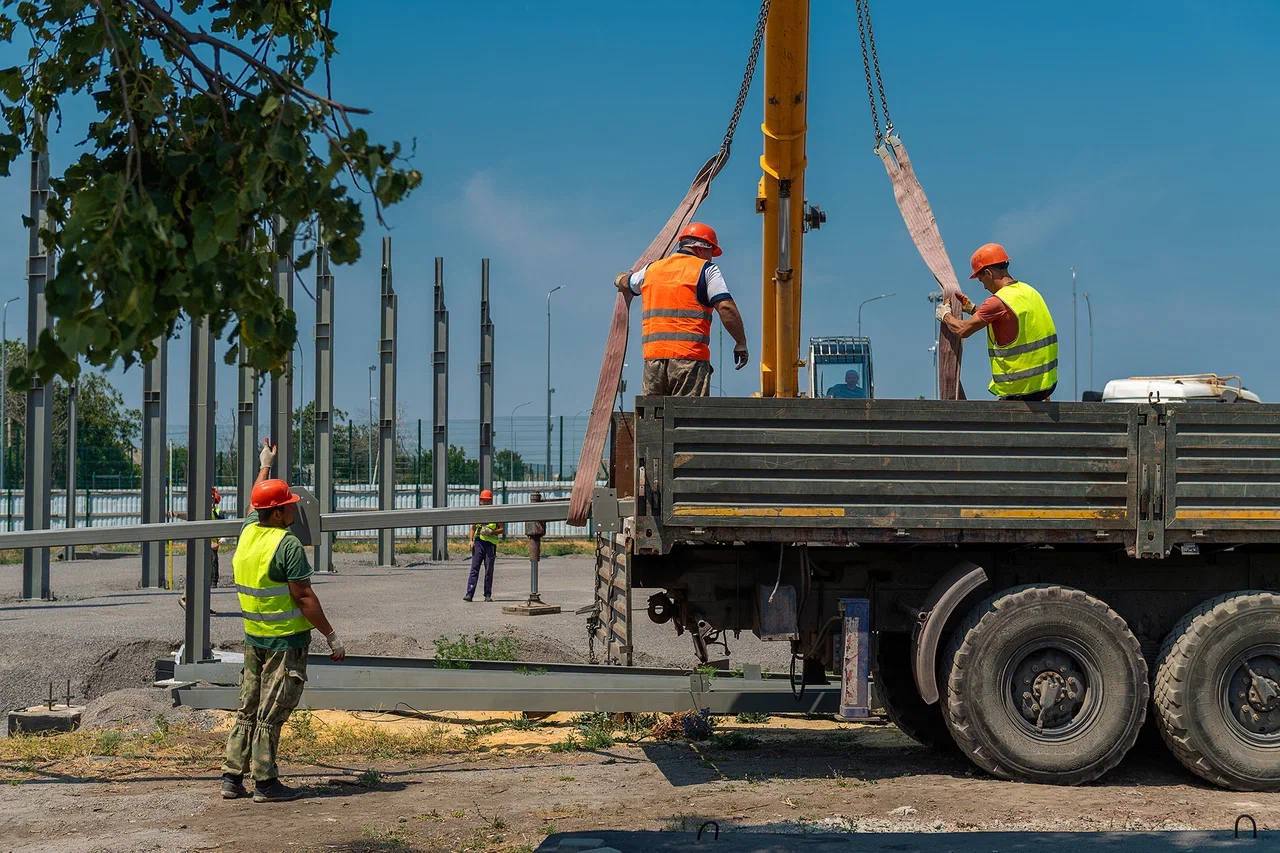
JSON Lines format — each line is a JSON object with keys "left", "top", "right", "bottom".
{"left": 937, "top": 243, "right": 1057, "bottom": 401}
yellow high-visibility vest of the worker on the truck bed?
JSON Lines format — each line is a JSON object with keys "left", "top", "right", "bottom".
{"left": 987, "top": 282, "right": 1057, "bottom": 397}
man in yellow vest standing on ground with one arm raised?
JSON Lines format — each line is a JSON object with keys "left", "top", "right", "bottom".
{"left": 223, "top": 439, "right": 347, "bottom": 803}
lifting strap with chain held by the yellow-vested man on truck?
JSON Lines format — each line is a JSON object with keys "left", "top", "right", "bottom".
{"left": 858, "top": 0, "right": 965, "bottom": 400}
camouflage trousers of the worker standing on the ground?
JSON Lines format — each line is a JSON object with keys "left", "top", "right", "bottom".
{"left": 223, "top": 643, "right": 307, "bottom": 783}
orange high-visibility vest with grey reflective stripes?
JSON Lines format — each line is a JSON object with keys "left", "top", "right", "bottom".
{"left": 640, "top": 254, "right": 712, "bottom": 361}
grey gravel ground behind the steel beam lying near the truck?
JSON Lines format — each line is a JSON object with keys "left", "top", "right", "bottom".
{"left": 0, "top": 545, "right": 787, "bottom": 708}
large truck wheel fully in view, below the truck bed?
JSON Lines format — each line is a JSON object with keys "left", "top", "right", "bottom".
{"left": 943, "top": 585, "right": 1149, "bottom": 785}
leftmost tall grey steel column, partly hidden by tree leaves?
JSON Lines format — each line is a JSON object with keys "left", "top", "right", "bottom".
{"left": 22, "top": 115, "right": 54, "bottom": 599}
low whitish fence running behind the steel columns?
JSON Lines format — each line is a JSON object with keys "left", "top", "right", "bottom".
{"left": 0, "top": 480, "right": 589, "bottom": 540}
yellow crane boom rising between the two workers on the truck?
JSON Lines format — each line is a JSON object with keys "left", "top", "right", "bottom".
{"left": 755, "top": 0, "right": 809, "bottom": 397}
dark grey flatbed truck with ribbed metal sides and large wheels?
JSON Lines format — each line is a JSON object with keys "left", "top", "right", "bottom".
{"left": 596, "top": 391, "right": 1280, "bottom": 790}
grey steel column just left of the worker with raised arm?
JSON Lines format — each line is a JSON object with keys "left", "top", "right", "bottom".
{"left": 182, "top": 318, "right": 215, "bottom": 663}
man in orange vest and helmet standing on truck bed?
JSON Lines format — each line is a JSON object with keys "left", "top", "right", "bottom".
{"left": 614, "top": 222, "right": 750, "bottom": 397}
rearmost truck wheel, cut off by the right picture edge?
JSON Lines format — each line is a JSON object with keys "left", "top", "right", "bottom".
{"left": 1153, "top": 590, "right": 1280, "bottom": 790}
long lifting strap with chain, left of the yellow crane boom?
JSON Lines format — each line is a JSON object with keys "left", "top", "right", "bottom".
{"left": 568, "top": 0, "right": 771, "bottom": 526}
